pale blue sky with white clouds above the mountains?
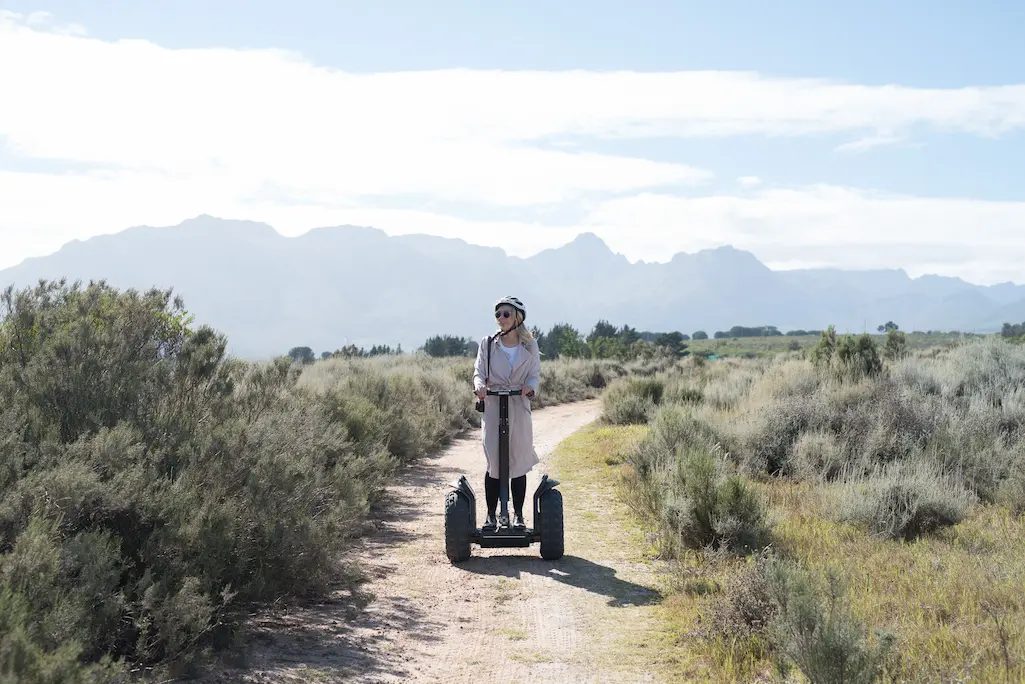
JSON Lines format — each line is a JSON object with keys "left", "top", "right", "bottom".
{"left": 0, "top": 0, "right": 1025, "bottom": 284}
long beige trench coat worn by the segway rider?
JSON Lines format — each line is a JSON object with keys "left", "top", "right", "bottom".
{"left": 474, "top": 335, "right": 541, "bottom": 479}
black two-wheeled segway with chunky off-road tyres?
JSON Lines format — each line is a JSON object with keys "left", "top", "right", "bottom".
{"left": 445, "top": 390, "right": 564, "bottom": 563}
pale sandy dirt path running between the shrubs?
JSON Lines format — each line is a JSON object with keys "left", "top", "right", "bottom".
{"left": 197, "top": 401, "right": 654, "bottom": 684}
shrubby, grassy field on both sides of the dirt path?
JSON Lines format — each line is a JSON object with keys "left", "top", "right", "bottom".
{"left": 0, "top": 283, "right": 1025, "bottom": 682}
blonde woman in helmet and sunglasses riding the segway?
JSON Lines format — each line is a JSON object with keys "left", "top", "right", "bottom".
{"left": 474, "top": 296, "right": 541, "bottom": 530}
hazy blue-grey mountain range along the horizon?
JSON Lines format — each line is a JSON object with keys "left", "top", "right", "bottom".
{"left": 0, "top": 216, "right": 1025, "bottom": 357}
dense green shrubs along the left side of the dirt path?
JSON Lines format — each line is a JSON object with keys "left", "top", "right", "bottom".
{"left": 0, "top": 281, "right": 672, "bottom": 682}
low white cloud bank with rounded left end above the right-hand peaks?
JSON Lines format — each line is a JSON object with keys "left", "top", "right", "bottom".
{"left": 586, "top": 186, "right": 1025, "bottom": 283}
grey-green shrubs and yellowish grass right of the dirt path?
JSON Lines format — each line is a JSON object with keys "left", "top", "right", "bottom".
{"left": 603, "top": 326, "right": 1025, "bottom": 682}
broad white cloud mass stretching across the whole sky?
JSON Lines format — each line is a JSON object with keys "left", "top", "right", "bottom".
{"left": 0, "top": 12, "right": 1025, "bottom": 282}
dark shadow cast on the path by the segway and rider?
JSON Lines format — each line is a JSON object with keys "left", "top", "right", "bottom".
{"left": 458, "top": 556, "right": 662, "bottom": 607}
